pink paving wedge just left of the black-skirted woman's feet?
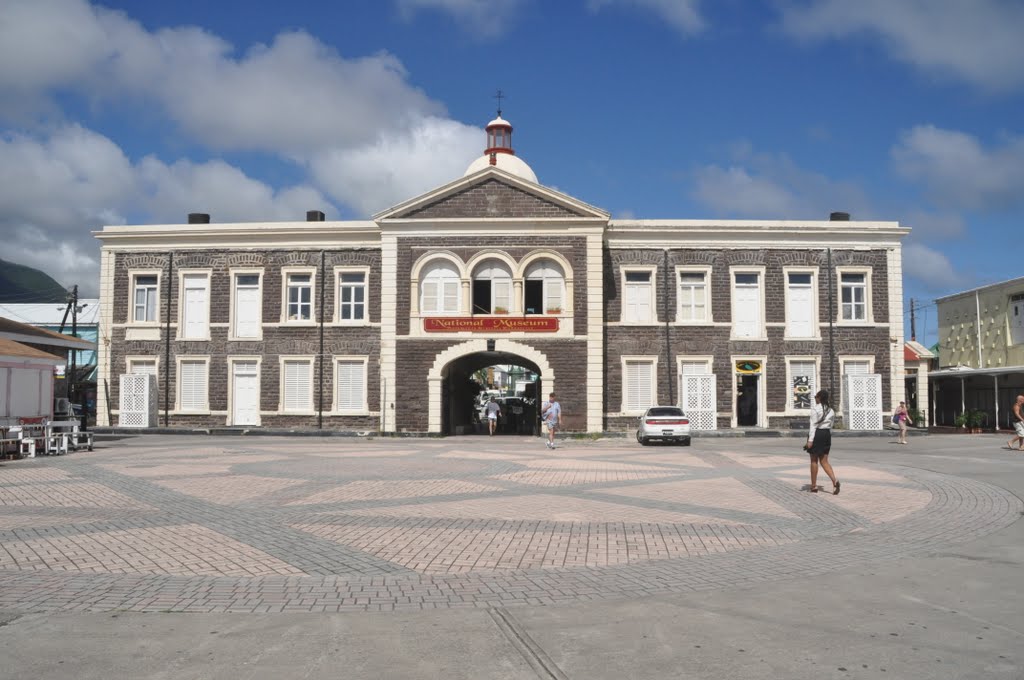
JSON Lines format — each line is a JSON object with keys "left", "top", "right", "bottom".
{"left": 601, "top": 477, "right": 797, "bottom": 517}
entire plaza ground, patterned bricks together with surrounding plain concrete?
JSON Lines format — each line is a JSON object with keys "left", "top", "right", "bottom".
{"left": 0, "top": 435, "right": 1024, "bottom": 678}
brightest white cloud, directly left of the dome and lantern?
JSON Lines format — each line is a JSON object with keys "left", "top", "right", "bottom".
{"left": 309, "top": 118, "right": 483, "bottom": 216}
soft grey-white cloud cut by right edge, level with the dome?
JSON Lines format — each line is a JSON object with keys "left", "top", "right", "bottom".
{"left": 892, "top": 125, "right": 1024, "bottom": 210}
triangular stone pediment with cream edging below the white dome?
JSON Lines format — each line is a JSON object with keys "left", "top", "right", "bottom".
{"left": 374, "top": 167, "right": 608, "bottom": 221}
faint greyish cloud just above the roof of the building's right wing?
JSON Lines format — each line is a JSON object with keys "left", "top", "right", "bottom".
{"left": 692, "top": 142, "right": 869, "bottom": 219}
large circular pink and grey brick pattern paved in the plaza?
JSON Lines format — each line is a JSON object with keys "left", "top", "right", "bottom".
{"left": 0, "top": 436, "right": 1022, "bottom": 611}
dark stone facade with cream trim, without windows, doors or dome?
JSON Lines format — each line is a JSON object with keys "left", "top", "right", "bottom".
{"left": 99, "top": 161, "right": 906, "bottom": 434}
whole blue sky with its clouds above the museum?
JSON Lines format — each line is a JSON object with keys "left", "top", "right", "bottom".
{"left": 0, "top": 0, "right": 1024, "bottom": 341}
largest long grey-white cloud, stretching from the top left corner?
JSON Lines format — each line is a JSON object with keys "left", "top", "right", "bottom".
{"left": 0, "top": 0, "right": 444, "bottom": 155}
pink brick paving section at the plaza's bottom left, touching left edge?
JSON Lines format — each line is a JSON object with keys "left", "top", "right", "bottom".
{"left": 0, "top": 524, "right": 302, "bottom": 577}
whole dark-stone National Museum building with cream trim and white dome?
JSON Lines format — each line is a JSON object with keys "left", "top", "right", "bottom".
{"left": 96, "top": 115, "right": 909, "bottom": 434}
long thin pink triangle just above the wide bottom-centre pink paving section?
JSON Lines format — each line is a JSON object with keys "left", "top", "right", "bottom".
{"left": 348, "top": 494, "right": 733, "bottom": 523}
